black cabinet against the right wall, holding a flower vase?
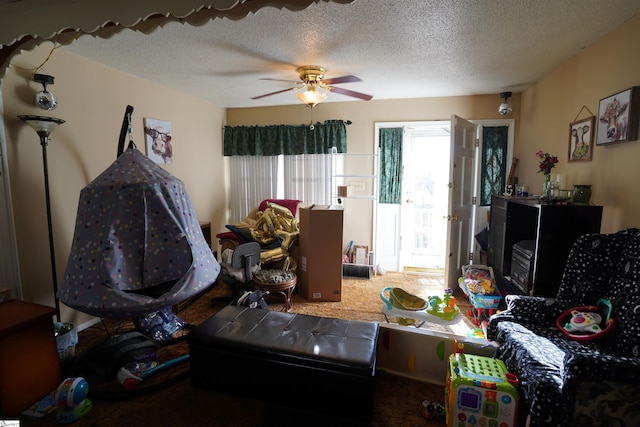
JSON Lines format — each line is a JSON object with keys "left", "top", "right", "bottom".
{"left": 487, "top": 195, "right": 602, "bottom": 297}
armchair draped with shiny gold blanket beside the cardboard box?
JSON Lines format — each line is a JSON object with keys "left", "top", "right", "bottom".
{"left": 216, "top": 199, "right": 302, "bottom": 271}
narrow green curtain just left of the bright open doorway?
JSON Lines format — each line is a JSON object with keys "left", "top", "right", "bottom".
{"left": 379, "top": 128, "right": 403, "bottom": 204}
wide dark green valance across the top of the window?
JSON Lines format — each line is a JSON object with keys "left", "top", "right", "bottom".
{"left": 224, "top": 120, "right": 347, "bottom": 156}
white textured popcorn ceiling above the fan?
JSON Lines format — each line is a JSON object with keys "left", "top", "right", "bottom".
{"left": 0, "top": 0, "right": 640, "bottom": 107}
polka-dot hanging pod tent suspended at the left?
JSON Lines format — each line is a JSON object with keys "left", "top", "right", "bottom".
{"left": 58, "top": 147, "right": 220, "bottom": 318}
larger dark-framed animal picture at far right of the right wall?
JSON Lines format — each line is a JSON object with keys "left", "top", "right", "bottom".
{"left": 596, "top": 86, "right": 640, "bottom": 145}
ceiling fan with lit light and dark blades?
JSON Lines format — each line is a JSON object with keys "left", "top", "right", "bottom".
{"left": 251, "top": 65, "right": 373, "bottom": 108}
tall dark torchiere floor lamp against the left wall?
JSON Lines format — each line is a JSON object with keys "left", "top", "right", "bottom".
{"left": 18, "top": 116, "right": 65, "bottom": 322}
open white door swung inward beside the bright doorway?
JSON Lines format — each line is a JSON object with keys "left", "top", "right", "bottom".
{"left": 445, "top": 115, "right": 478, "bottom": 289}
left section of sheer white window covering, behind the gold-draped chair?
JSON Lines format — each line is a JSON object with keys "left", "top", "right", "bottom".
{"left": 230, "top": 156, "right": 279, "bottom": 224}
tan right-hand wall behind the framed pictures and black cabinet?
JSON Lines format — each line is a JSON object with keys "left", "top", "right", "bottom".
{"left": 515, "top": 15, "right": 640, "bottom": 232}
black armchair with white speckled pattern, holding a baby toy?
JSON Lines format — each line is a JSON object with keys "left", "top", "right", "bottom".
{"left": 487, "top": 229, "right": 640, "bottom": 426}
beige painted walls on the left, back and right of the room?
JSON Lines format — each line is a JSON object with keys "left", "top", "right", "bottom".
{"left": 2, "top": 15, "right": 640, "bottom": 323}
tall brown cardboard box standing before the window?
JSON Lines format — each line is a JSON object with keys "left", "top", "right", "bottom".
{"left": 298, "top": 205, "right": 344, "bottom": 301}
